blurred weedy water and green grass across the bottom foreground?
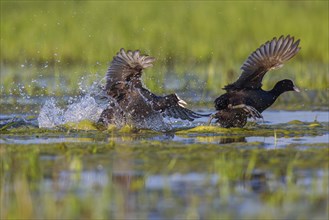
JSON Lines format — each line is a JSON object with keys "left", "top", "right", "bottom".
{"left": 1, "top": 147, "right": 328, "bottom": 219}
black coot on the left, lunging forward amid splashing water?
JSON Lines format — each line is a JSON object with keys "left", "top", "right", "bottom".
{"left": 99, "top": 49, "right": 209, "bottom": 131}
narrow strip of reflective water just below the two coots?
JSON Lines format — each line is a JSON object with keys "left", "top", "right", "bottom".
{"left": 0, "top": 129, "right": 329, "bottom": 149}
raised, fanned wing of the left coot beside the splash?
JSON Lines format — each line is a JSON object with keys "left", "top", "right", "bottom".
{"left": 105, "top": 49, "right": 155, "bottom": 98}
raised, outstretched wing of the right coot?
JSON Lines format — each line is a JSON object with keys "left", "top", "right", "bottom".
{"left": 224, "top": 35, "right": 300, "bottom": 91}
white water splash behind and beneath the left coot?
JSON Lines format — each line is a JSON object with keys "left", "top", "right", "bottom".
{"left": 38, "top": 77, "right": 204, "bottom": 132}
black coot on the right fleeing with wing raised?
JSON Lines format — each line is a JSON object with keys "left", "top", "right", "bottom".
{"left": 209, "top": 35, "right": 300, "bottom": 128}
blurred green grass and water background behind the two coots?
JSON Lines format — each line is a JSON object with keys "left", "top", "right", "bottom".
{"left": 0, "top": 1, "right": 329, "bottom": 99}
